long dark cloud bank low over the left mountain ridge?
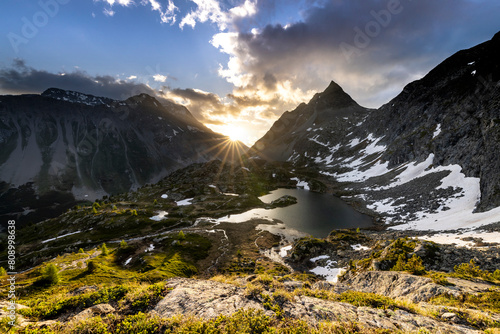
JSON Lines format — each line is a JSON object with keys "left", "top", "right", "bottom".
{"left": 0, "top": 59, "right": 156, "bottom": 100}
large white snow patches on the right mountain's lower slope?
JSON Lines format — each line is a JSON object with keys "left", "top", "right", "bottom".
{"left": 308, "top": 130, "right": 500, "bottom": 231}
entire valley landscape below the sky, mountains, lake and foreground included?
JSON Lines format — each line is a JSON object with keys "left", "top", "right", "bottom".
{"left": 0, "top": 33, "right": 500, "bottom": 334}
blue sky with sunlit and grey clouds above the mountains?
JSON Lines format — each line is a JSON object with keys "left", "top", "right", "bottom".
{"left": 0, "top": 0, "right": 500, "bottom": 145}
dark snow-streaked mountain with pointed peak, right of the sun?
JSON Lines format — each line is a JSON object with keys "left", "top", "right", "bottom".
{"left": 252, "top": 33, "right": 500, "bottom": 228}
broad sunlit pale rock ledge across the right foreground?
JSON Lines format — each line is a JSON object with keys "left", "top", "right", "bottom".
{"left": 152, "top": 271, "right": 500, "bottom": 333}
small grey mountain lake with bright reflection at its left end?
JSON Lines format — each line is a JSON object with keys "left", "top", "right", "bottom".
{"left": 220, "top": 189, "right": 373, "bottom": 238}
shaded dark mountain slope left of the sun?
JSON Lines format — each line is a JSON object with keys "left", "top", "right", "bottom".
{"left": 0, "top": 88, "right": 243, "bottom": 224}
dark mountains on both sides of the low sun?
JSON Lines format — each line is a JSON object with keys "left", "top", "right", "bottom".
{"left": 0, "top": 33, "right": 500, "bottom": 229}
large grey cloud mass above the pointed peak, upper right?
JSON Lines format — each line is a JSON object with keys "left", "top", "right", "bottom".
{"left": 217, "top": 0, "right": 500, "bottom": 106}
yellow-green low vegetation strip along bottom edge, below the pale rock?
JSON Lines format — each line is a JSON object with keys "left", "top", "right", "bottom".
{"left": 12, "top": 309, "right": 387, "bottom": 334}
